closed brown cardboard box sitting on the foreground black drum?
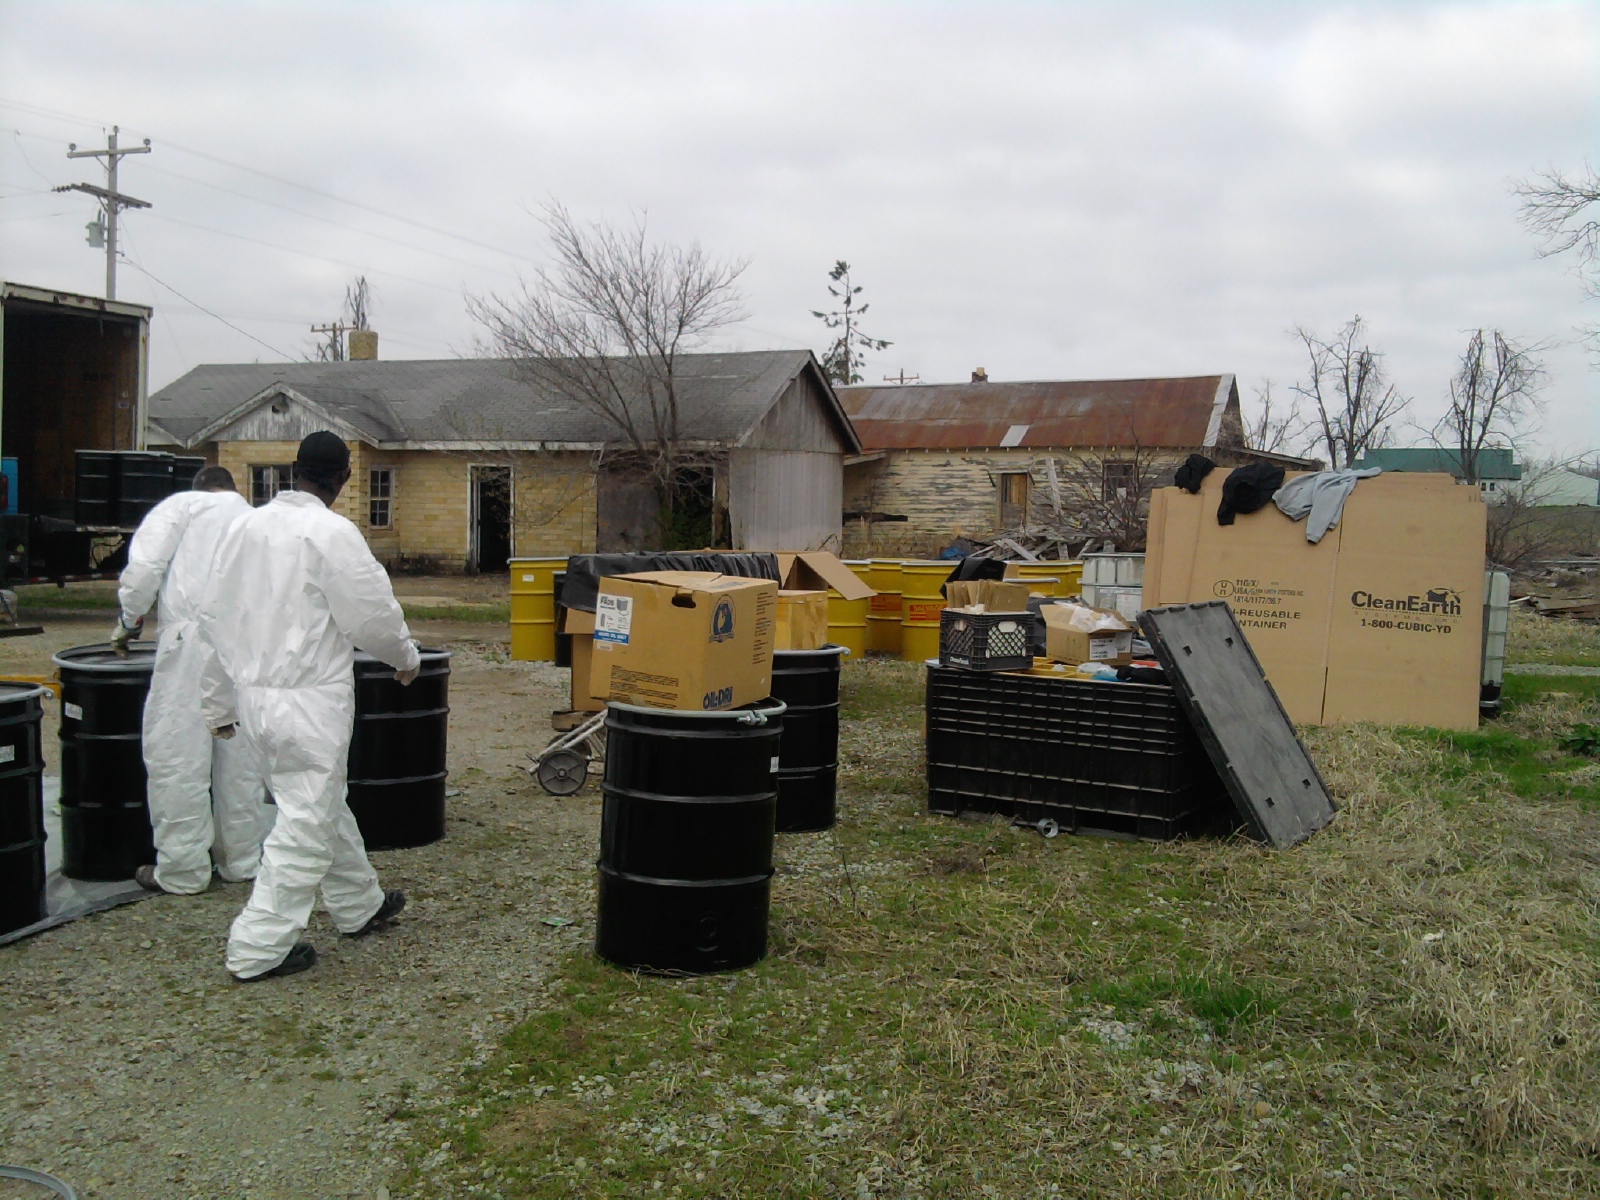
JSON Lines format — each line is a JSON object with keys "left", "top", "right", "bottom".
{"left": 595, "top": 571, "right": 778, "bottom": 710}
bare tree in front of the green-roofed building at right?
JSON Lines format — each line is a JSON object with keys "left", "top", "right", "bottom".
{"left": 1432, "top": 330, "right": 1544, "bottom": 485}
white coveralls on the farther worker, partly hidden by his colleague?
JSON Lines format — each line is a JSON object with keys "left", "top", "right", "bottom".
{"left": 117, "top": 491, "right": 272, "bottom": 894}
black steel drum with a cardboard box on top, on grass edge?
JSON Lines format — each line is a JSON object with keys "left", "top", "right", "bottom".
{"left": 595, "top": 701, "right": 784, "bottom": 974}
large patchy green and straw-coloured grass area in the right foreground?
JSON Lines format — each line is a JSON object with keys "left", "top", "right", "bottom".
{"left": 390, "top": 662, "right": 1600, "bottom": 1200}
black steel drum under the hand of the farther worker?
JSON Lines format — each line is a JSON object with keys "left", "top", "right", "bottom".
{"left": 53, "top": 643, "right": 155, "bottom": 880}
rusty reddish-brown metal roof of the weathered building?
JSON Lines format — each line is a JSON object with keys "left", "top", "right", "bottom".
{"left": 835, "top": 374, "right": 1238, "bottom": 451}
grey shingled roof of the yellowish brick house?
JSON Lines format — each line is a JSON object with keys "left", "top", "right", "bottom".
{"left": 149, "top": 350, "right": 858, "bottom": 450}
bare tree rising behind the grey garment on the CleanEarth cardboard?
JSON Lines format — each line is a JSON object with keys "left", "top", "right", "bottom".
{"left": 1293, "top": 315, "right": 1411, "bottom": 467}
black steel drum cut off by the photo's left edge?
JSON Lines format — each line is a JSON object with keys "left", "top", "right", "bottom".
{"left": 0, "top": 682, "right": 45, "bottom": 933}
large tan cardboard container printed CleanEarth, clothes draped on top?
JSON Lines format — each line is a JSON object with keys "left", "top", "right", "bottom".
{"left": 1144, "top": 470, "right": 1486, "bottom": 730}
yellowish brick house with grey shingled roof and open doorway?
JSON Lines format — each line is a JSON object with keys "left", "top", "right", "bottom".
{"left": 150, "top": 350, "right": 861, "bottom": 571}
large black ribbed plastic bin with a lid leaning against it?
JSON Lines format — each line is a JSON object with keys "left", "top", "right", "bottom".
{"left": 928, "top": 667, "right": 1237, "bottom": 840}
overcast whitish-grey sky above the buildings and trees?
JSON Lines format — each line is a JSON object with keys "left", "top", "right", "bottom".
{"left": 0, "top": 0, "right": 1600, "bottom": 453}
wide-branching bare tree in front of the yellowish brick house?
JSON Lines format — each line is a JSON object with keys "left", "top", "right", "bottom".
{"left": 467, "top": 203, "right": 746, "bottom": 528}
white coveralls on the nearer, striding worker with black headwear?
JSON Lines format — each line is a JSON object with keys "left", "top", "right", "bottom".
{"left": 200, "top": 491, "right": 421, "bottom": 979}
